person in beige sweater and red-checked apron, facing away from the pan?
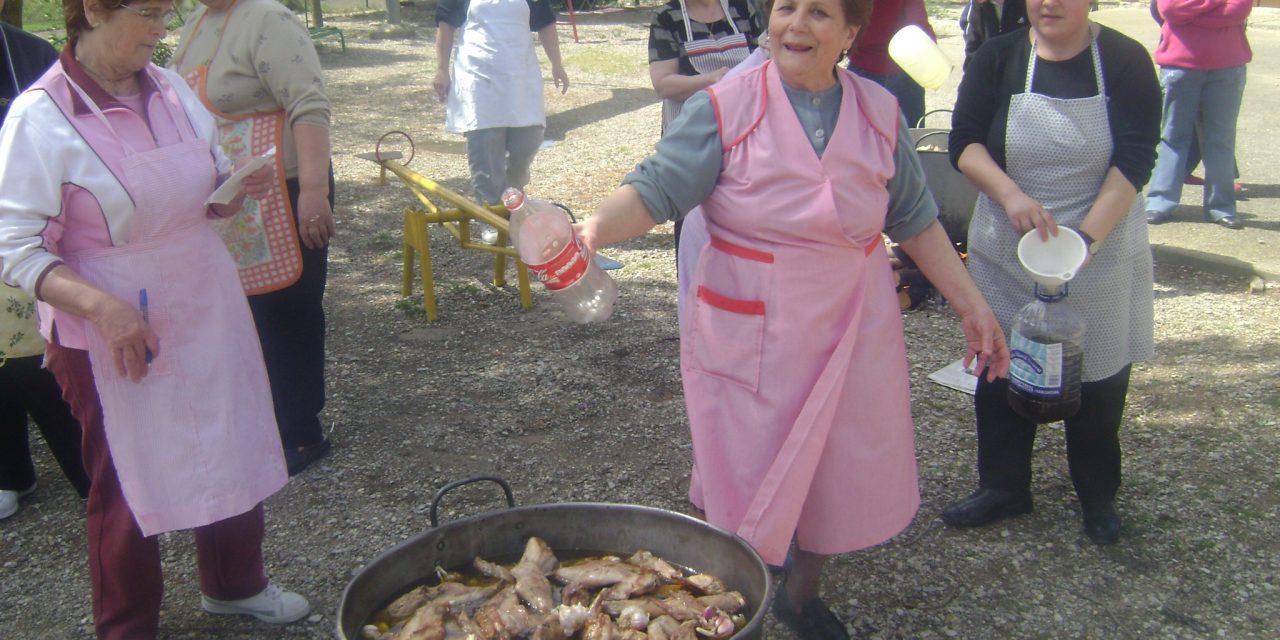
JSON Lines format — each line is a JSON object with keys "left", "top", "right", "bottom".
{"left": 170, "top": 0, "right": 337, "bottom": 476}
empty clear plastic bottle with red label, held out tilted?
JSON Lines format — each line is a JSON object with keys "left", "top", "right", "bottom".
{"left": 503, "top": 193, "right": 618, "bottom": 323}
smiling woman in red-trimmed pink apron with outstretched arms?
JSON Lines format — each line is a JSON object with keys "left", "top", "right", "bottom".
{"left": 580, "top": 0, "right": 1009, "bottom": 639}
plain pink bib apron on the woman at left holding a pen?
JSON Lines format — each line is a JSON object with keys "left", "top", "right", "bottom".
{"left": 50, "top": 73, "right": 288, "bottom": 535}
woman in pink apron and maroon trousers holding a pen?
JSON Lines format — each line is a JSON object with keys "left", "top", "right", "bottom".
{"left": 0, "top": 0, "right": 310, "bottom": 640}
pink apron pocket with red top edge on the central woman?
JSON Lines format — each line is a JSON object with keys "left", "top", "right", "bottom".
{"left": 689, "top": 287, "right": 764, "bottom": 392}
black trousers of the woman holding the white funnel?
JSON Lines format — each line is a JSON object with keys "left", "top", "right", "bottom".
{"left": 973, "top": 365, "right": 1132, "bottom": 506}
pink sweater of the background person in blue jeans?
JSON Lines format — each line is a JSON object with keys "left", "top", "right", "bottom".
{"left": 1156, "top": 0, "right": 1253, "bottom": 70}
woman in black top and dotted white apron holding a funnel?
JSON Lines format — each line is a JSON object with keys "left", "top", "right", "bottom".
{"left": 942, "top": 0, "right": 1160, "bottom": 544}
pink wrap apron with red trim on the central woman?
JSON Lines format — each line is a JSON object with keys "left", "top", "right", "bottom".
{"left": 681, "top": 63, "right": 919, "bottom": 564}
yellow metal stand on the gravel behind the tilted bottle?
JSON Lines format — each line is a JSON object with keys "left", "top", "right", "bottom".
{"left": 361, "top": 154, "right": 534, "bottom": 320}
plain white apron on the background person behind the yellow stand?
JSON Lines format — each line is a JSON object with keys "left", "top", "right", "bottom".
{"left": 444, "top": 0, "right": 547, "bottom": 133}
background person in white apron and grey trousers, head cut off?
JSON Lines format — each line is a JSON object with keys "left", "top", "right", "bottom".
{"left": 431, "top": 0, "right": 568, "bottom": 243}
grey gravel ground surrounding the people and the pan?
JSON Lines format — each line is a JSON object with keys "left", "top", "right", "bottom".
{"left": 0, "top": 6, "right": 1280, "bottom": 639}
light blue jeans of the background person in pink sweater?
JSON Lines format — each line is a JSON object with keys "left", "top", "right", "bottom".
{"left": 1147, "top": 65, "right": 1244, "bottom": 221}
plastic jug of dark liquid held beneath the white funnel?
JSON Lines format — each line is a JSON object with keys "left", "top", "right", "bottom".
{"left": 1009, "top": 284, "right": 1084, "bottom": 424}
